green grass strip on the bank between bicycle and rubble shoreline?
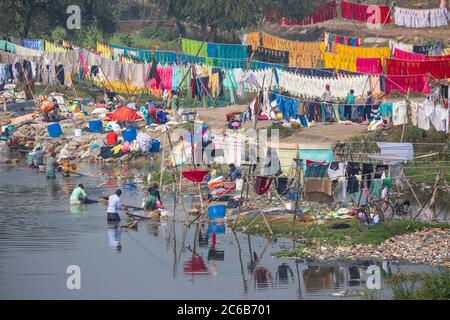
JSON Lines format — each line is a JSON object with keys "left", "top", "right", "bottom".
{"left": 239, "top": 217, "right": 450, "bottom": 250}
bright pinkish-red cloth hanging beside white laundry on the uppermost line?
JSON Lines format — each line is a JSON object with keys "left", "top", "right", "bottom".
{"left": 341, "top": 0, "right": 391, "bottom": 24}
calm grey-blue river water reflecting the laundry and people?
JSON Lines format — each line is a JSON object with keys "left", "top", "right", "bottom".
{"left": 0, "top": 165, "right": 431, "bottom": 299}
